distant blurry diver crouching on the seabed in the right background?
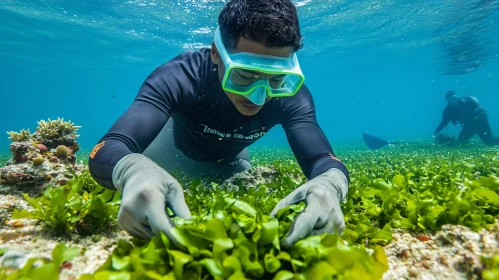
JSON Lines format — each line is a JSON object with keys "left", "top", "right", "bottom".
{"left": 433, "top": 90, "right": 499, "bottom": 145}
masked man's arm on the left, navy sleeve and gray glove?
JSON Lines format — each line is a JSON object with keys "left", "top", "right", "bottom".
{"left": 89, "top": 51, "right": 207, "bottom": 244}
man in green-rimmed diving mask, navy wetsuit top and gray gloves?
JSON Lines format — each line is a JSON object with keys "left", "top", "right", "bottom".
{"left": 89, "top": 0, "right": 349, "bottom": 247}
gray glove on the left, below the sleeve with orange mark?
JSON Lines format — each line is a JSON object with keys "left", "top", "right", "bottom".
{"left": 113, "top": 153, "right": 191, "bottom": 245}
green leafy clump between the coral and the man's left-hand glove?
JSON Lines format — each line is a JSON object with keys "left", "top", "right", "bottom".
{"left": 12, "top": 170, "right": 120, "bottom": 234}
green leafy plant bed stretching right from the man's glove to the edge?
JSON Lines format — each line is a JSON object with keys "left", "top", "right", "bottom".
{"left": 342, "top": 147, "right": 499, "bottom": 246}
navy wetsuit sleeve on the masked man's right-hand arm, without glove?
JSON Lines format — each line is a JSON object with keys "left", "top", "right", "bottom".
{"left": 281, "top": 85, "right": 350, "bottom": 182}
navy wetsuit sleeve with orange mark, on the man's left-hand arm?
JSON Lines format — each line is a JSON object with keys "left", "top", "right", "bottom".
{"left": 88, "top": 53, "right": 199, "bottom": 189}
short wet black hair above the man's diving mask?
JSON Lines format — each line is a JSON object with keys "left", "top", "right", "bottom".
{"left": 218, "top": 0, "right": 303, "bottom": 52}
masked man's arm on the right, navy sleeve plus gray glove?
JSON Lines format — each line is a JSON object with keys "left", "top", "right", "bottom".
{"left": 270, "top": 85, "right": 350, "bottom": 248}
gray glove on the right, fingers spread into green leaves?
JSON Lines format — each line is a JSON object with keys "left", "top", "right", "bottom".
{"left": 270, "top": 168, "right": 348, "bottom": 248}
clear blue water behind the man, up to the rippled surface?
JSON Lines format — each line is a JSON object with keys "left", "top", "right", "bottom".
{"left": 0, "top": 0, "right": 499, "bottom": 153}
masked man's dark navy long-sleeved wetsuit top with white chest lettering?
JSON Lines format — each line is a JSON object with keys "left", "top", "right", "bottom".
{"left": 89, "top": 48, "right": 348, "bottom": 189}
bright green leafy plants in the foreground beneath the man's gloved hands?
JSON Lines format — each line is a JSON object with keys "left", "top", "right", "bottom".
{"left": 80, "top": 201, "right": 388, "bottom": 280}
